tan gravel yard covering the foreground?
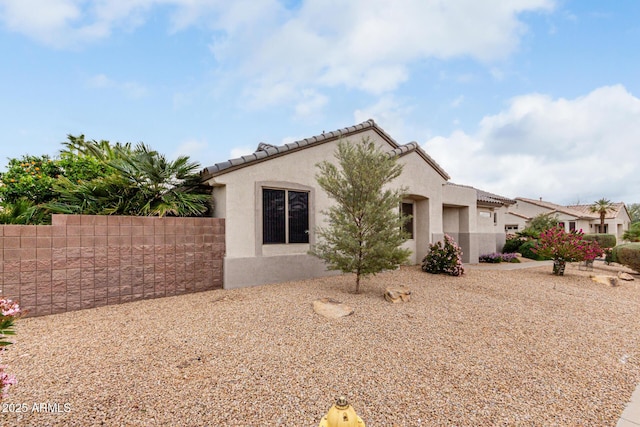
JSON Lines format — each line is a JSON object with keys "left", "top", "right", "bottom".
{"left": 0, "top": 266, "right": 640, "bottom": 427}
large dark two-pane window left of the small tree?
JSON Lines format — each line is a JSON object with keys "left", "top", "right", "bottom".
{"left": 262, "top": 188, "right": 309, "bottom": 244}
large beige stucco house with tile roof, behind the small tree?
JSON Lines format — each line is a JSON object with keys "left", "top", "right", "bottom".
{"left": 201, "top": 120, "right": 514, "bottom": 289}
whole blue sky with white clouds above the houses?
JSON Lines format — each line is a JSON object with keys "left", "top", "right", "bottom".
{"left": 0, "top": 0, "right": 640, "bottom": 204}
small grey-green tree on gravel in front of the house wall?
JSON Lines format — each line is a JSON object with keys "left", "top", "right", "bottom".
{"left": 311, "top": 138, "right": 410, "bottom": 293}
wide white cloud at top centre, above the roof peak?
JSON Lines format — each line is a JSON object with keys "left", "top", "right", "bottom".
{"left": 235, "top": 0, "right": 553, "bottom": 104}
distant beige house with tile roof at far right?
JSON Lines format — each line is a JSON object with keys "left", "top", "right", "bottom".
{"left": 505, "top": 197, "right": 631, "bottom": 241}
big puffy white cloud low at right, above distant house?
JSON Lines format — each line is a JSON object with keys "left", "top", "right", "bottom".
{"left": 424, "top": 86, "right": 640, "bottom": 203}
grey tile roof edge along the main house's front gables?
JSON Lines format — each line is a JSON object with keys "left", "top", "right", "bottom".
{"left": 200, "top": 119, "right": 450, "bottom": 180}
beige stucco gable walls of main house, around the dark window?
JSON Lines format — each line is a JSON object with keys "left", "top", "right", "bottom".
{"left": 209, "top": 129, "right": 445, "bottom": 288}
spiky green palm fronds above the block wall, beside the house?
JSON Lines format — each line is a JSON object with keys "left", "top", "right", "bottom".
{"left": 46, "top": 141, "right": 211, "bottom": 216}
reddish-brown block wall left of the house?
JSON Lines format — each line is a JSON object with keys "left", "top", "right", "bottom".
{"left": 0, "top": 215, "right": 225, "bottom": 316}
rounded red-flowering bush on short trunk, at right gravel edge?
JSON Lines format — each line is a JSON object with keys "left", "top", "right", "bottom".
{"left": 531, "top": 227, "right": 603, "bottom": 276}
